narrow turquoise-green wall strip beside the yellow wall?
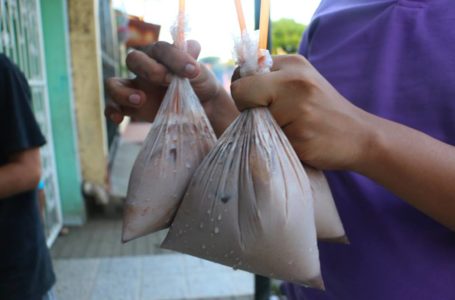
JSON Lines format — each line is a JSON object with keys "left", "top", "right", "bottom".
{"left": 41, "top": 0, "right": 86, "bottom": 225}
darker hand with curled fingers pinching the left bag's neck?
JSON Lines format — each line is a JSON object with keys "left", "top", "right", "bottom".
{"left": 105, "top": 41, "right": 222, "bottom": 124}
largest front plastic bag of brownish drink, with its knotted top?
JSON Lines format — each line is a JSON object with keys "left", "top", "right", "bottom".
{"left": 162, "top": 32, "right": 323, "bottom": 289}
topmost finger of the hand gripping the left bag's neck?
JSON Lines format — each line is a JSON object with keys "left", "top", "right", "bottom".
{"left": 146, "top": 41, "right": 200, "bottom": 78}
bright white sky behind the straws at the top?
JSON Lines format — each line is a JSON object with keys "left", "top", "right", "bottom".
{"left": 113, "top": 0, "right": 320, "bottom": 61}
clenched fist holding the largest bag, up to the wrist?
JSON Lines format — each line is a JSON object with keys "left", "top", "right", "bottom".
{"left": 231, "top": 55, "right": 370, "bottom": 169}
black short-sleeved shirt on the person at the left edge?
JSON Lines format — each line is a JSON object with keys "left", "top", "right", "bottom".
{"left": 0, "top": 53, "right": 55, "bottom": 300}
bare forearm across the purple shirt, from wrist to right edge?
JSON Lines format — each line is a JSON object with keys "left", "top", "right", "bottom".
{"left": 354, "top": 115, "right": 455, "bottom": 230}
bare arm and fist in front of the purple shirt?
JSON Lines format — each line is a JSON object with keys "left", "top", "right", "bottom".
{"left": 231, "top": 55, "right": 455, "bottom": 231}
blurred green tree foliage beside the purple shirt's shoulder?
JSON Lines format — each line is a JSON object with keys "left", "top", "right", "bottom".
{"left": 272, "top": 19, "right": 306, "bottom": 54}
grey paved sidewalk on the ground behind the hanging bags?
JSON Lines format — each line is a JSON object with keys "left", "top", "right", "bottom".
{"left": 52, "top": 123, "right": 254, "bottom": 300}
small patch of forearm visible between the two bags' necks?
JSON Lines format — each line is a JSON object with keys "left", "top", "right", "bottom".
{"left": 203, "top": 86, "right": 239, "bottom": 137}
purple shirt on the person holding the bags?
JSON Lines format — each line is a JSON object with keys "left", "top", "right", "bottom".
{"left": 283, "top": 0, "right": 455, "bottom": 300}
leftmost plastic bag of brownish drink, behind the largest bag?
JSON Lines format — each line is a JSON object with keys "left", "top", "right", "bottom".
{"left": 122, "top": 15, "right": 216, "bottom": 242}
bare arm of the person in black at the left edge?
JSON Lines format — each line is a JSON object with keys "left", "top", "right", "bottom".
{"left": 0, "top": 148, "right": 41, "bottom": 199}
